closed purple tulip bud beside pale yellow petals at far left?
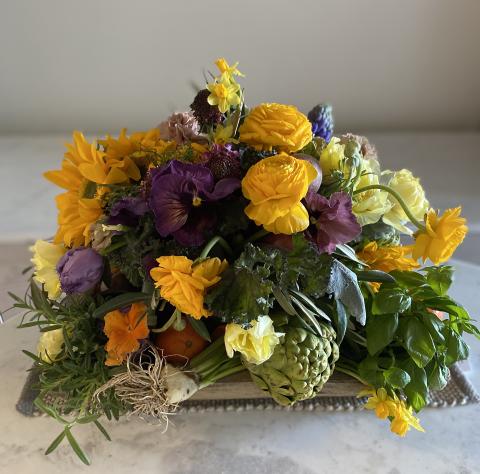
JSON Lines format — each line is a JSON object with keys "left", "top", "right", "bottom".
{"left": 57, "top": 247, "right": 103, "bottom": 295}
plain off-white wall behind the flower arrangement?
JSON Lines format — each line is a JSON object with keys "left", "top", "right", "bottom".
{"left": 0, "top": 0, "right": 480, "bottom": 133}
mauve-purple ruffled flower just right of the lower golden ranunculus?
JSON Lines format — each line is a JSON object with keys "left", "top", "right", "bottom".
{"left": 305, "top": 192, "right": 362, "bottom": 253}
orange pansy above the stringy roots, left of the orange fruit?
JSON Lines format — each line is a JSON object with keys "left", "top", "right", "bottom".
{"left": 103, "top": 303, "right": 149, "bottom": 365}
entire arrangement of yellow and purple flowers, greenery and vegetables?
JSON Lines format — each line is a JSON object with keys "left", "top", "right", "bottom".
{"left": 5, "top": 59, "right": 480, "bottom": 463}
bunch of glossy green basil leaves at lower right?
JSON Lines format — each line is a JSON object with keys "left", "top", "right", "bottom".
{"left": 340, "top": 266, "right": 479, "bottom": 411}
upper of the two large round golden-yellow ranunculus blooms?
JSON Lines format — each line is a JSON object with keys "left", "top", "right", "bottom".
{"left": 239, "top": 104, "right": 312, "bottom": 153}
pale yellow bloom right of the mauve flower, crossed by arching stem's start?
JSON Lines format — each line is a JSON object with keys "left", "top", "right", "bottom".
{"left": 352, "top": 160, "right": 392, "bottom": 227}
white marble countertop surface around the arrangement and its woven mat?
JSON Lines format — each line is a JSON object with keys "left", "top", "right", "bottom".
{"left": 0, "top": 133, "right": 480, "bottom": 474}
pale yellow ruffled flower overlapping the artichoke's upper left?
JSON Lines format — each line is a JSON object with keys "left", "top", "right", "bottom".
{"left": 225, "top": 316, "right": 284, "bottom": 365}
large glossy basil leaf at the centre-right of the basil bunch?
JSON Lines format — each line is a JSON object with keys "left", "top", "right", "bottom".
{"left": 401, "top": 316, "right": 435, "bottom": 367}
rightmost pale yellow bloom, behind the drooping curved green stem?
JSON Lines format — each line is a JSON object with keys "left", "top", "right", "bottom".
{"left": 383, "top": 169, "right": 429, "bottom": 235}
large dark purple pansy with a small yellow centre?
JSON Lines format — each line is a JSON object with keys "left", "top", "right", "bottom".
{"left": 149, "top": 160, "right": 240, "bottom": 247}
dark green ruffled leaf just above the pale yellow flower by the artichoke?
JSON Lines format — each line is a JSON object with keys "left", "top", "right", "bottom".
{"left": 205, "top": 267, "right": 273, "bottom": 324}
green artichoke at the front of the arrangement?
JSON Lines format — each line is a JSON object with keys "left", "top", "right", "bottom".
{"left": 244, "top": 313, "right": 339, "bottom": 405}
